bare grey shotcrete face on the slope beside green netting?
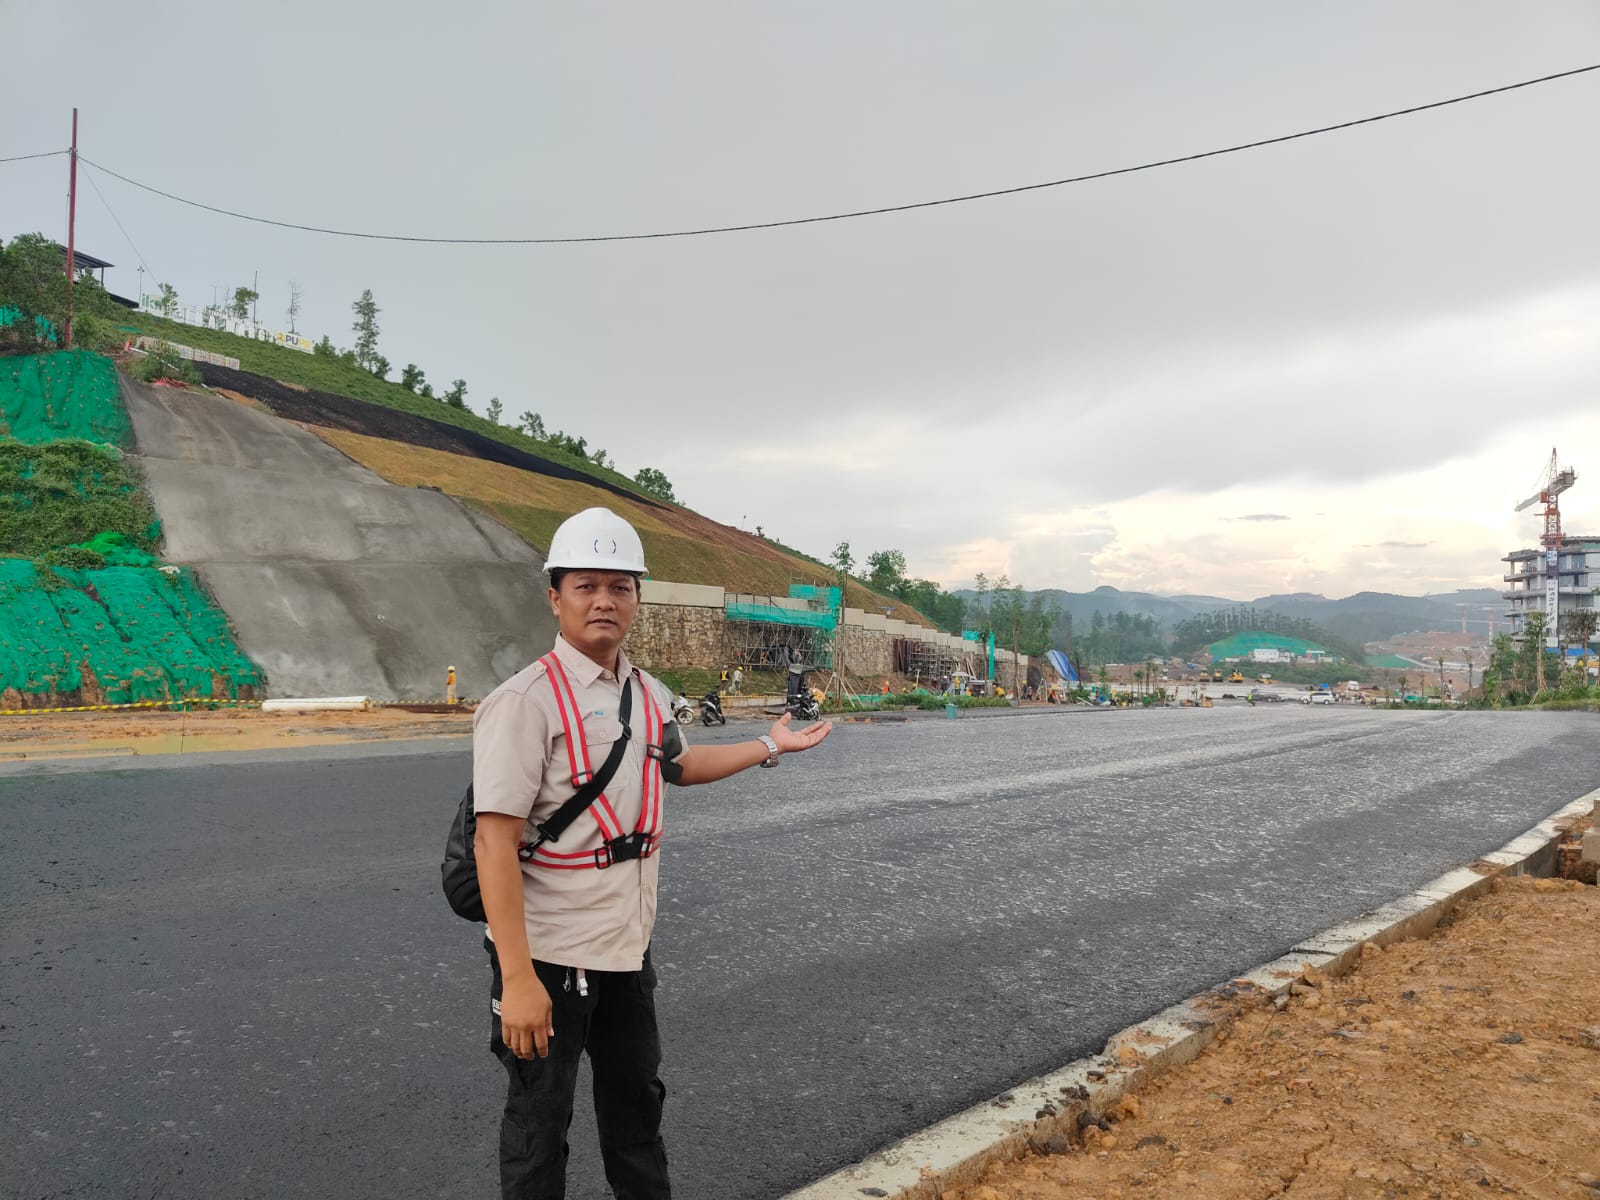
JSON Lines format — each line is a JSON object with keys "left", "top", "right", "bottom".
{"left": 122, "top": 378, "right": 555, "bottom": 699}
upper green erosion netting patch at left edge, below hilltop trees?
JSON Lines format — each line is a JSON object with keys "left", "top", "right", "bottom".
{"left": 0, "top": 350, "right": 128, "bottom": 446}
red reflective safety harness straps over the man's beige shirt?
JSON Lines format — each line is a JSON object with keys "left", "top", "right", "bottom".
{"left": 517, "top": 653, "right": 664, "bottom": 870}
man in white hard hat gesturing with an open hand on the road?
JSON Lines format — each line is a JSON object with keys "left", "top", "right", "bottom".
{"left": 472, "top": 509, "right": 832, "bottom": 1200}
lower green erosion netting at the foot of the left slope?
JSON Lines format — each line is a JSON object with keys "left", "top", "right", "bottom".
{"left": 0, "top": 558, "right": 261, "bottom": 709}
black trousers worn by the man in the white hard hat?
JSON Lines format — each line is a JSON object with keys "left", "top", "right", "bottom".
{"left": 483, "top": 939, "right": 672, "bottom": 1200}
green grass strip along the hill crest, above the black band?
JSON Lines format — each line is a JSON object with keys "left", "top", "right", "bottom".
{"left": 123, "top": 312, "right": 638, "bottom": 491}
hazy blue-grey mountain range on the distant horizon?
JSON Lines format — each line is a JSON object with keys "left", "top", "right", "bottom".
{"left": 958, "top": 587, "right": 1504, "bottom": 643}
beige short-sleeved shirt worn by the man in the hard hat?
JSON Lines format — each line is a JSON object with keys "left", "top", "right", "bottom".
{"left": 472, "top": 635, "right": 672, "bottom": 971}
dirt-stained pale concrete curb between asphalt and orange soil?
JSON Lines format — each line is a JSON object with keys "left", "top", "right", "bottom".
{"left": 784, "top": 789, "right": 1600, "bottom": 1200}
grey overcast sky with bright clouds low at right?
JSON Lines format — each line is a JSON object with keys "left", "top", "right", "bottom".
{"left": 0, "top": 0, "right": 1600, "bottom": 611}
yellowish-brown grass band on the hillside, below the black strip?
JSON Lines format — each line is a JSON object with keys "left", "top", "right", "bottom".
{"left": 314, "top": 429, "right": 928, "bottom": 626}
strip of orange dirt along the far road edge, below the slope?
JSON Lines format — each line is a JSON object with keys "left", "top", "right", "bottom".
{"left": 0, "top": 709, "right": 472, "bottom": 762}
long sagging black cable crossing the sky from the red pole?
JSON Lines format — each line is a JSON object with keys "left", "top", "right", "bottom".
{"left": 78, "top": 62, "right": 1600, "bottom": 246}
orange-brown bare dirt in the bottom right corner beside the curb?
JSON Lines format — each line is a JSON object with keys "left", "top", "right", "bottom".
{"left": 944, "top": 851, "right": 1600, "bottom": 1200}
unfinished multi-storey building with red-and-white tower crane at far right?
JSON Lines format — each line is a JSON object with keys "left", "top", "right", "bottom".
{"left": 1501, "top": 450, "right": 1600, "bottom": 650}
